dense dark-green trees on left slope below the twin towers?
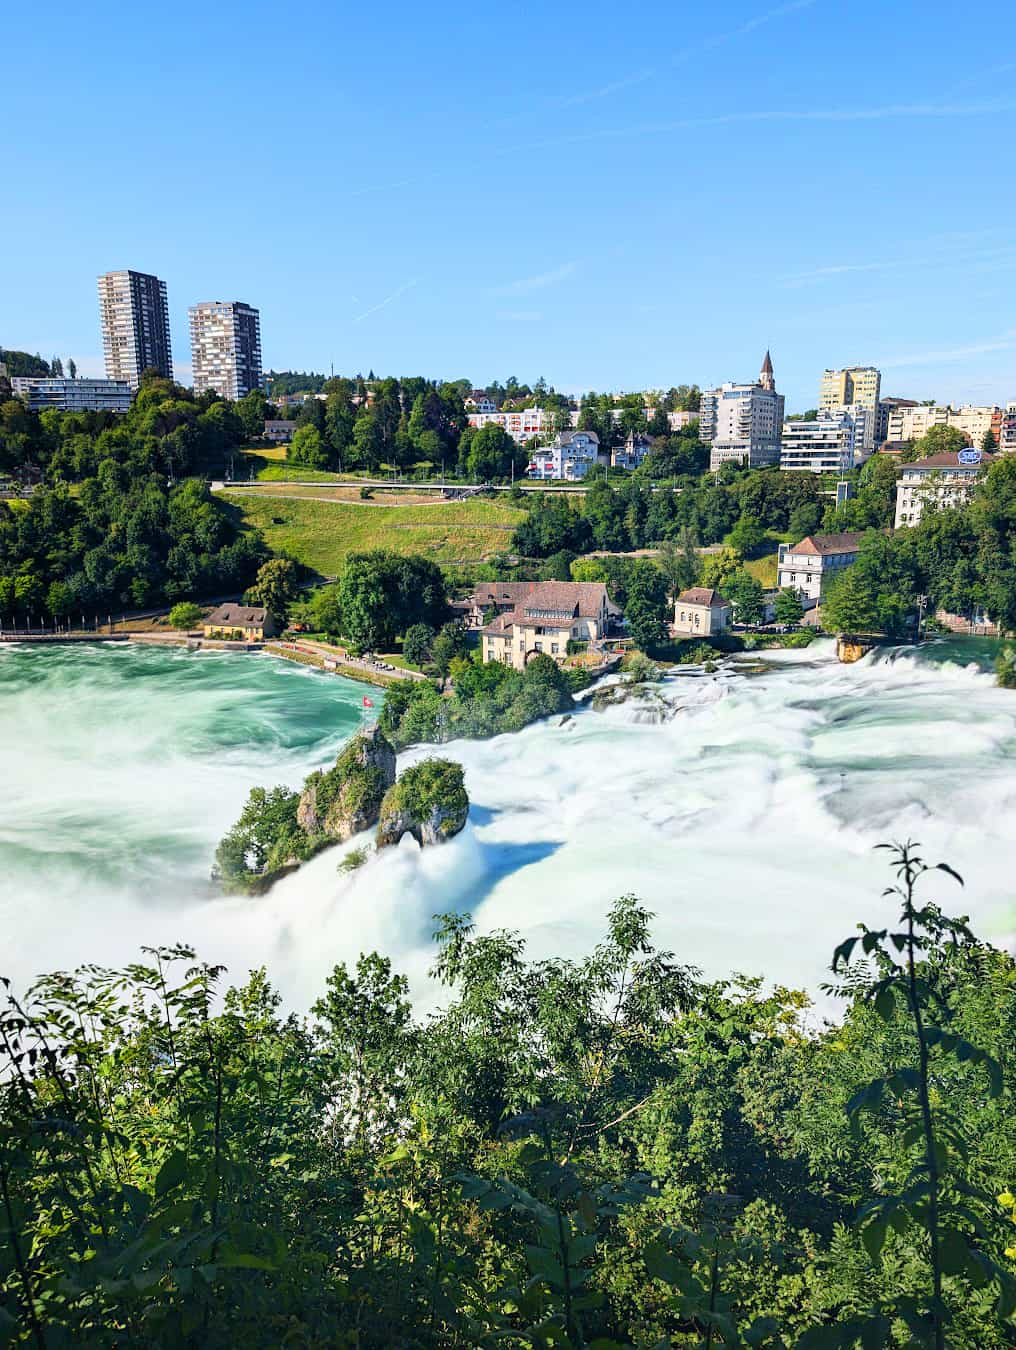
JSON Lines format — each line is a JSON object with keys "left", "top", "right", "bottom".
{"left": 0, "top": 379, "right": 266, "bottom": 620}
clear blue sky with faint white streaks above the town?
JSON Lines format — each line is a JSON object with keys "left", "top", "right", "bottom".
{"left": 0, "top": 0, "right": 1016, "bottom": 408}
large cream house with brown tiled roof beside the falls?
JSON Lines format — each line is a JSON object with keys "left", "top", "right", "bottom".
{"left": 482, "top": 582, "right": 611, "bottom": 671}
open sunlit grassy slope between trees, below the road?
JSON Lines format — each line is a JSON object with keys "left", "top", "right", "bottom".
{"left": 217, "top": 490, "right": 525, "bottom": 576}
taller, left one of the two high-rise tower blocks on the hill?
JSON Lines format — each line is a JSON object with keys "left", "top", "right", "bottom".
{"left": 98, "top": 269, "right": 173, "bottom": 390}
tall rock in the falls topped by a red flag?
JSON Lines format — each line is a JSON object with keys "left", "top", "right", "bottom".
{"left": 297, "top": 726, "right": 395, "bottom": 844}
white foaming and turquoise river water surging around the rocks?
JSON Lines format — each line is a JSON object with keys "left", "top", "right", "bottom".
{"left": 0, "top": 643, "right": 1016, "bottom": 1008}
